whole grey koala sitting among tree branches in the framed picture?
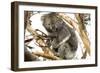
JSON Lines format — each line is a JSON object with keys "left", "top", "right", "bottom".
{"left": 41, "top": 12, "right": 78, "bottom": 59}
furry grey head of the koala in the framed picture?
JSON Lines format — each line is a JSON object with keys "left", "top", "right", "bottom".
{"left": 41, "top": 12, "right": 60, "bottom": 32}
